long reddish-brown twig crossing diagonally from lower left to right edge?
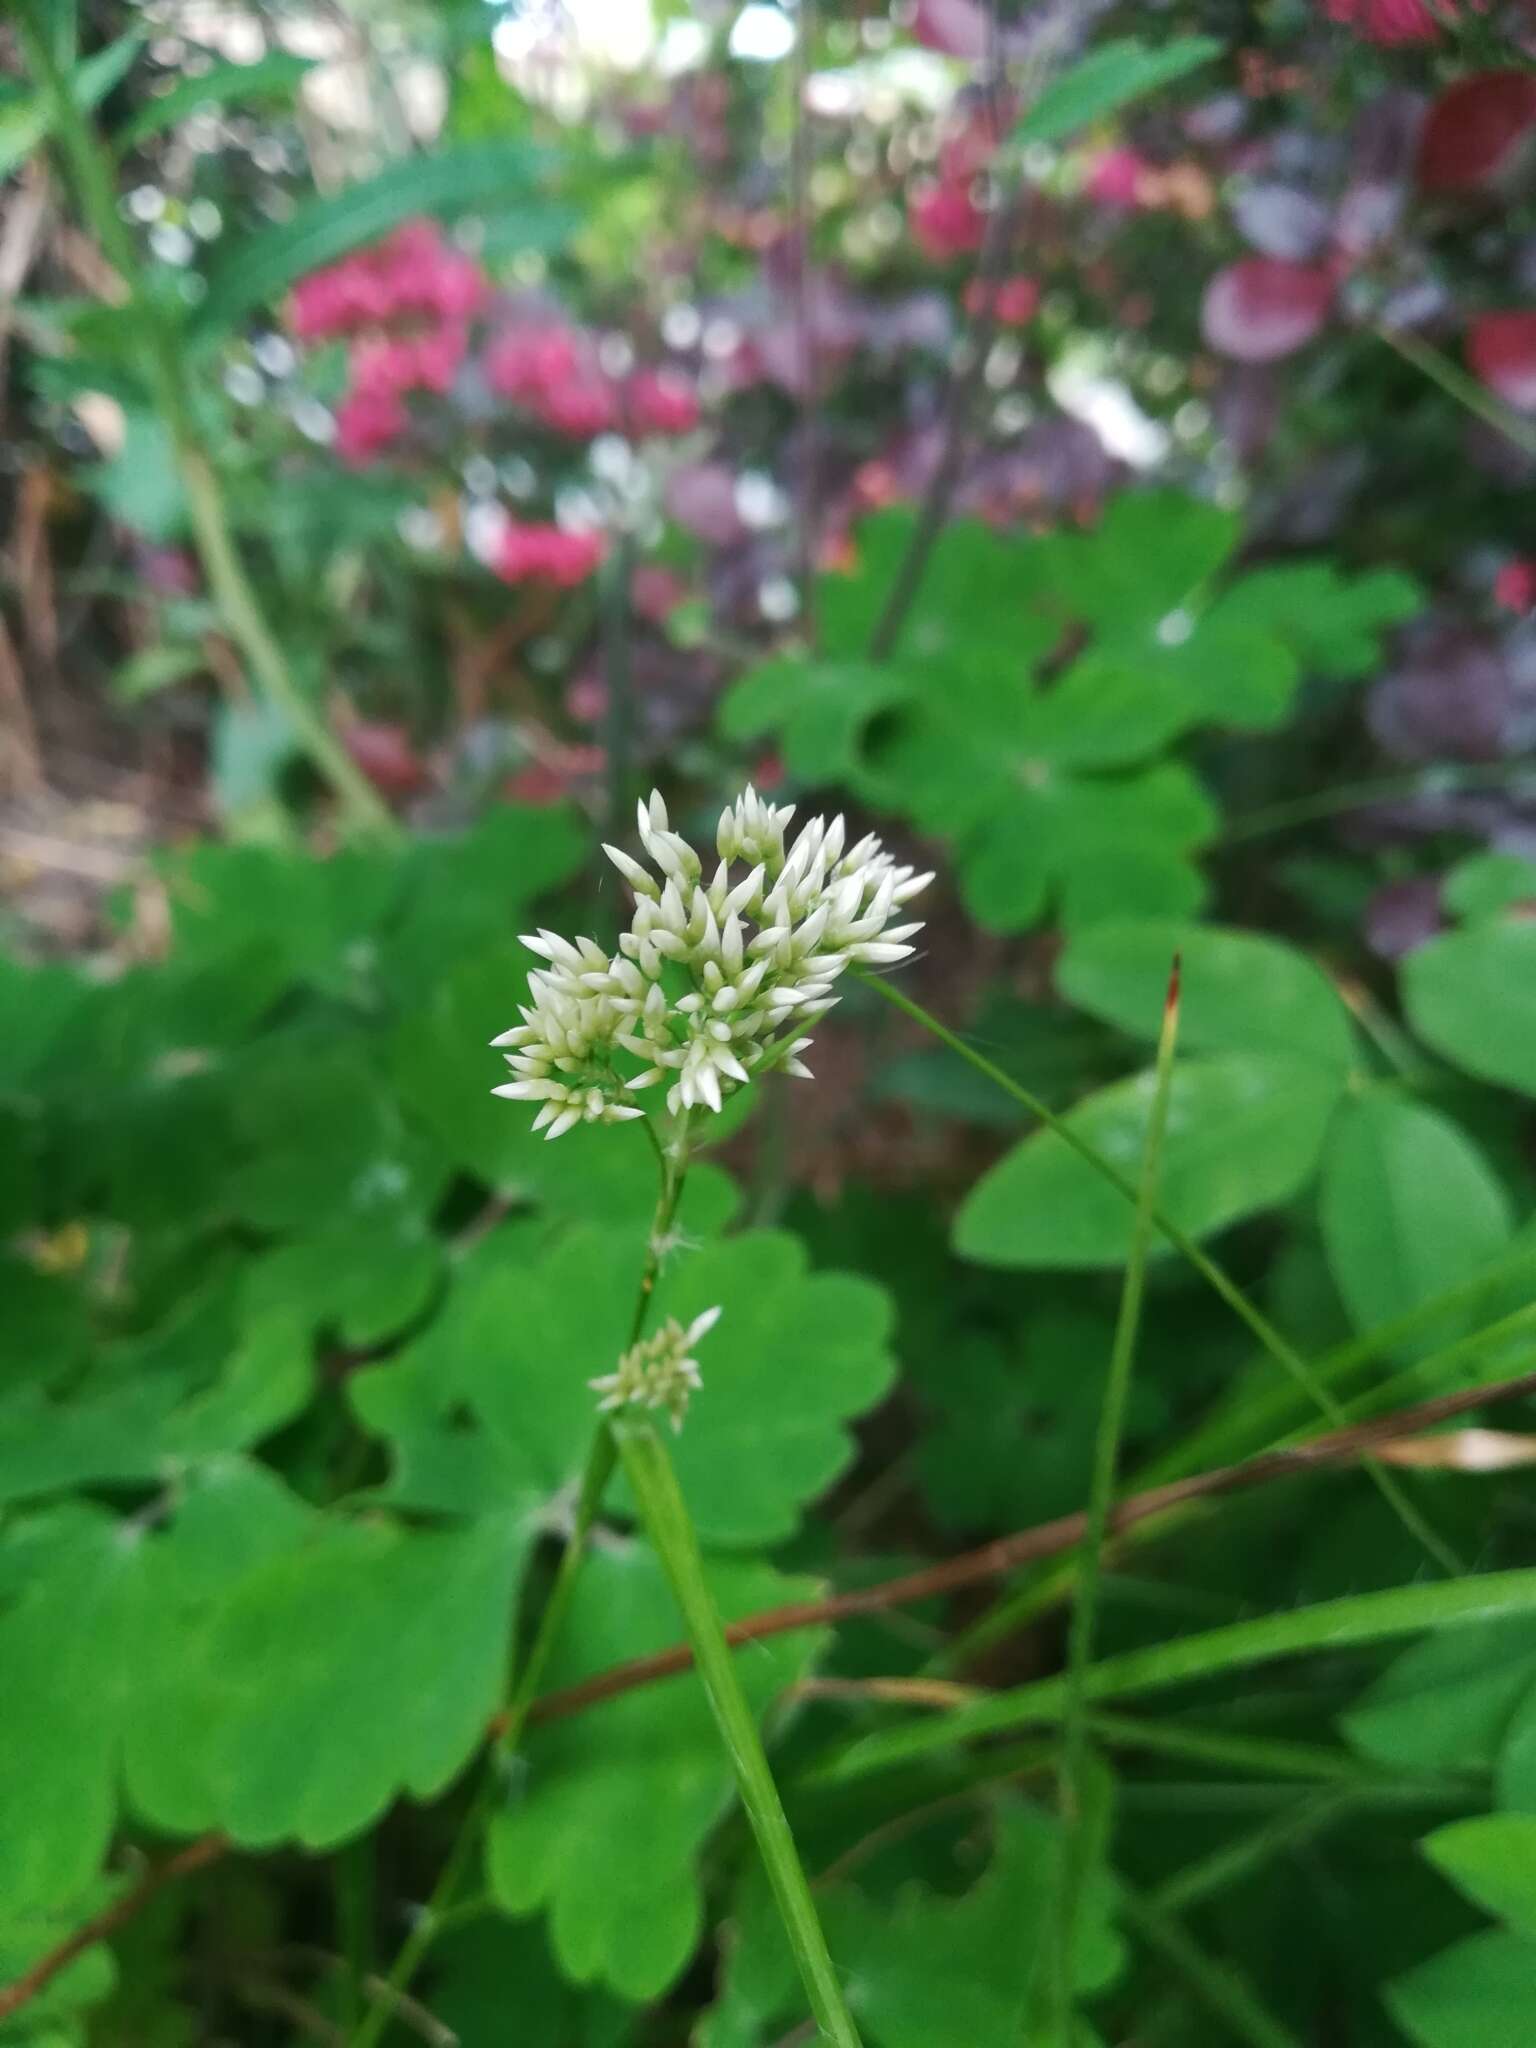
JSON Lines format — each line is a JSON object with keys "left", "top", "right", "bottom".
{"left": 12, "top": 1372, "right": 1536, "bottom": 2019}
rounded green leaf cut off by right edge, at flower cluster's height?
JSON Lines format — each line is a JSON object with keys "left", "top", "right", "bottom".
{"left": 1403, "top": 918, "right": 1536, "bottom": 1096}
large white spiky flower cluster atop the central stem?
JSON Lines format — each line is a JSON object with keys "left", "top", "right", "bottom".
{"left": 492, "top": 786, "right": 932, "bottom": 1139}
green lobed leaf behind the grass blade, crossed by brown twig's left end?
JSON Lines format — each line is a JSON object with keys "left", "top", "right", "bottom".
{"left": 487, "top": 1544, "right": 831, "bottom": 1999}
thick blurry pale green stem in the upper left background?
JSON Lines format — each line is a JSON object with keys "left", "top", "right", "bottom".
{"left": 16, "top": 0, "right": 397, "bottom": 834}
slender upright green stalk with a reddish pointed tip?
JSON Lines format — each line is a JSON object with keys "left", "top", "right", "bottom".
{"left": 1055, "top": 956, "right": 1180, "bottom": 2042}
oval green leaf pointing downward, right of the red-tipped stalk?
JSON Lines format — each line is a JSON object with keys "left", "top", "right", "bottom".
{"left": 1319, "top": 1090, "right": 1513, "bottom": 1356}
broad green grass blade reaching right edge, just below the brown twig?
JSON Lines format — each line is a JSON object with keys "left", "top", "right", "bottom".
{"left": 805, "top": 1569, "right": 1536, "bottom": 1786}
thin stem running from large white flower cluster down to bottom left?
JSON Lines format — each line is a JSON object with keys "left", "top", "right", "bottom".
{"left": 348, "top": 1110, "right": 688, "bottom": 2048}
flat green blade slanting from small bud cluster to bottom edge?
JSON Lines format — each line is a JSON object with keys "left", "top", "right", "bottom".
{"left": 614, "top": 1421, "right": 858, "bottom": 2048}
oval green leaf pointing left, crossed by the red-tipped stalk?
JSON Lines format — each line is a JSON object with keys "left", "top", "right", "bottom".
{"left": 954, "top": 1053, "right": 1341, "bottom": 1268}
